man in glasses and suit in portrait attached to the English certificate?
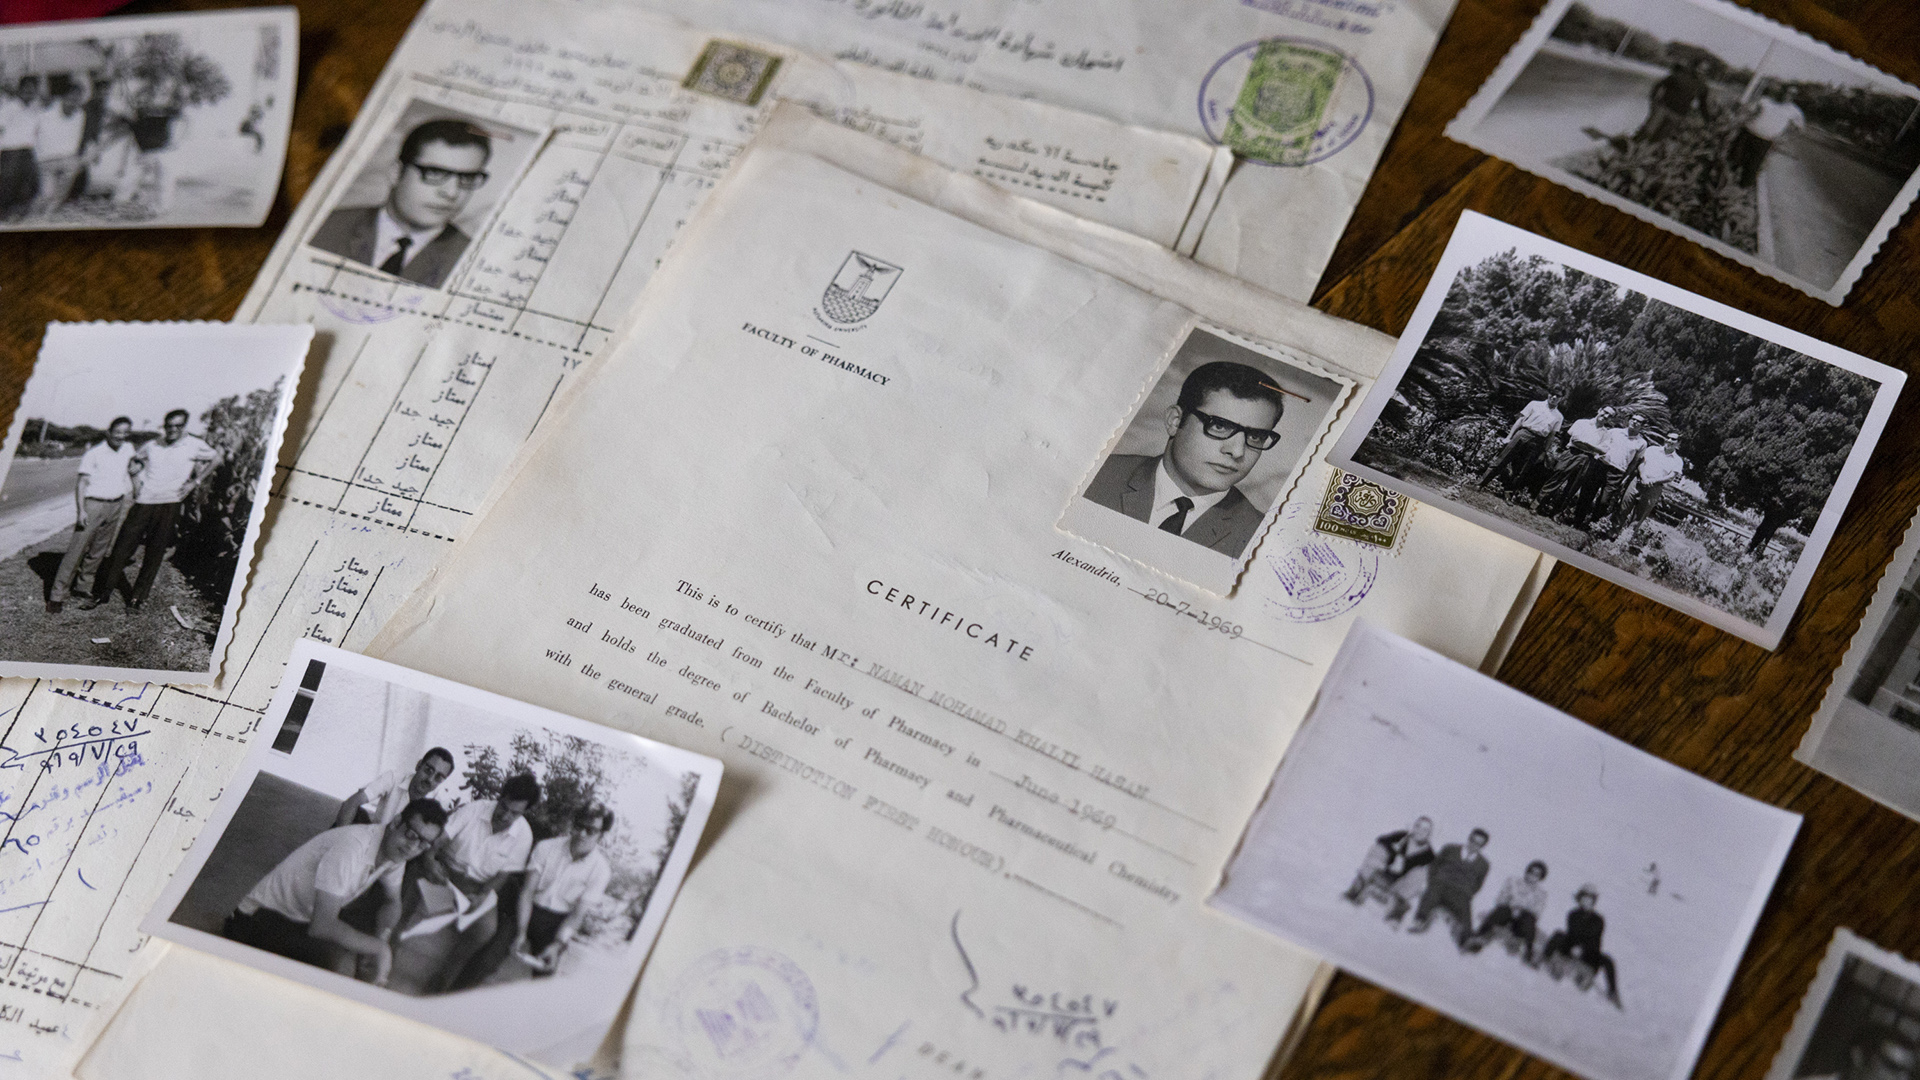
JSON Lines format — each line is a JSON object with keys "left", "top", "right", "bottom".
{"left": 1087, "top": 359, "right": 1286, "bottom": 559}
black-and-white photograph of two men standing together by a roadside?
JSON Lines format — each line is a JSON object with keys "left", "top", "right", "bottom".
{"left": 0, "top": 323, "right": 313, "bottom": 684}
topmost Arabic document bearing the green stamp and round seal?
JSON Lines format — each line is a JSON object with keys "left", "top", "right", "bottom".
{"left": 625, "top": 0, "right": 1453, "bottom": 300}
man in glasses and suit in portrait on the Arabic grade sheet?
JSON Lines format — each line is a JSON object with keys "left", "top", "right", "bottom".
{"left": 307, "top": 119, "right": 493, "bottom": 288}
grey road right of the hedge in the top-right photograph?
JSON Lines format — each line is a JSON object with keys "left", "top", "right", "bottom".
{"left": 1763, "top": 131, "right": 1901, "bottom": 286}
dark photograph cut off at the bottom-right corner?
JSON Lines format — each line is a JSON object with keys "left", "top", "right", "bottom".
{"left": 1766, "top": 928, "right": 1920, "bottom": 1080}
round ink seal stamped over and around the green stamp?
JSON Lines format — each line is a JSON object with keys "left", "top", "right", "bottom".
{"left": 1200, "top": 38, "right": 1373, "bottom": 165}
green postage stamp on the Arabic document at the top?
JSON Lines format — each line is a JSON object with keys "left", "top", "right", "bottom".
{"left": 1223, "top": 40, "right": 1346, "bottom": 165}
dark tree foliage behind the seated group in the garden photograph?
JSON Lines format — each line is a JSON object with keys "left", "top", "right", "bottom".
{"left": 1377, "top": 250, "right": 1878, "bottom": 552}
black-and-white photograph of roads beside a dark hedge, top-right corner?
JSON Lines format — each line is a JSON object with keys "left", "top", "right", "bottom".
{"left": 1448, "top": 0, "right": 1920, "bottom": 306}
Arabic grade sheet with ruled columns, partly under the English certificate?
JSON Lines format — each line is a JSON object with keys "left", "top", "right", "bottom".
{"left": 0, "top": 0, "right": 1219, "bottom": 1074}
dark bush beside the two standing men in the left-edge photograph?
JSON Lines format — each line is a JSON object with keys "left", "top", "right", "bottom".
{"left": 173, "top": 379, "right": 284, "bottom": 595}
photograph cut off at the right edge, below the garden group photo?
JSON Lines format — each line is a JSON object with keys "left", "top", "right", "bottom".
{"left": 1793, "top": 499, "right": 1920, "bottom": 821}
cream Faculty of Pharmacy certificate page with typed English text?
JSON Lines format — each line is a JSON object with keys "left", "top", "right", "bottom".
{"left": 357, "top": 146, "right": 1534, "bottom": 1078}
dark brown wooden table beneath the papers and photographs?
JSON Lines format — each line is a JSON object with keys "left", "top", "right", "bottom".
{"left": 0, "top": 0, "right": 1920, "bottom": 1080}
